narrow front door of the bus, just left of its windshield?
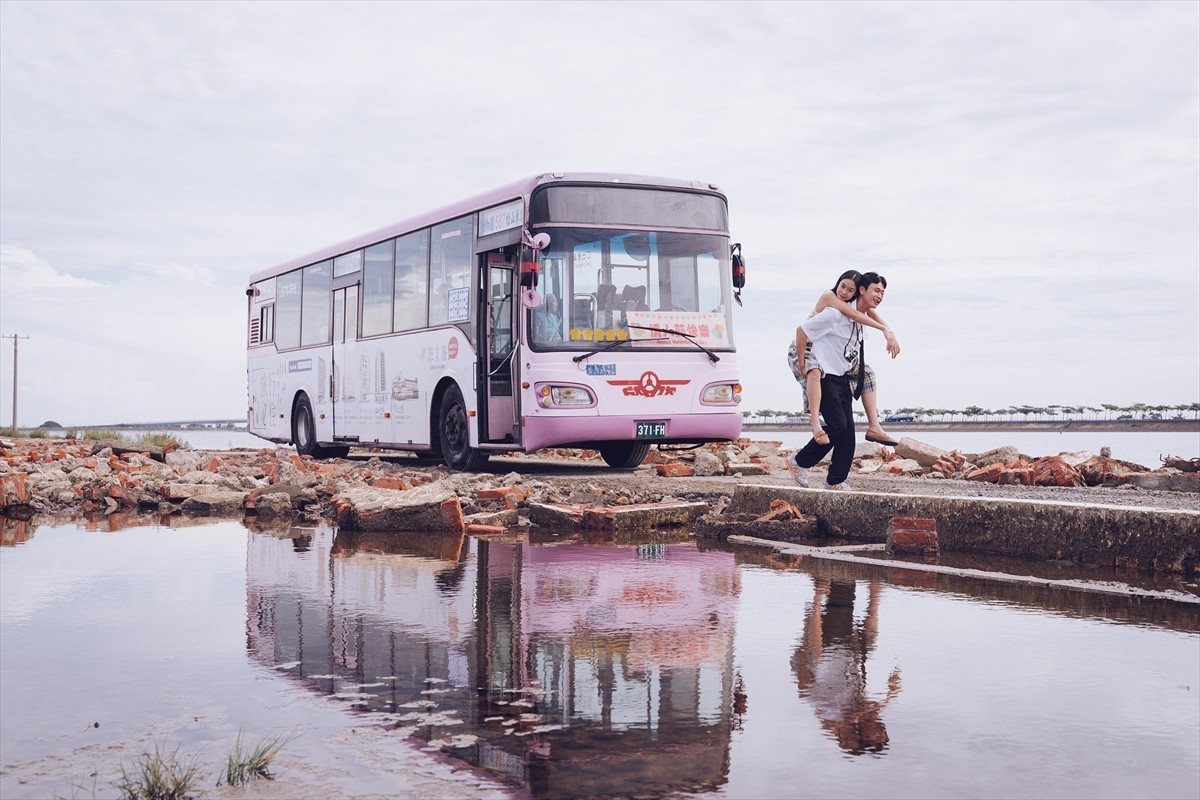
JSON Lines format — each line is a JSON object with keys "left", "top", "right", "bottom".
{"left": 479, "top": 252, "right": 517, "bottom": 443}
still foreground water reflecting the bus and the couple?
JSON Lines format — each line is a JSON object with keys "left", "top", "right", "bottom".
{"left": 0, "top": 522, "right": 1200, "bottom": 800}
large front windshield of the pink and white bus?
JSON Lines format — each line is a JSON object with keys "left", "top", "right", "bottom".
{"left": 529, "top": 227, "right": 733, "bottom": 350}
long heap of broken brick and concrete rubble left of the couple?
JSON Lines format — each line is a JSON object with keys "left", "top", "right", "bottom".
{"left": 0, "top": 439, "right": 720, "bottom": 534}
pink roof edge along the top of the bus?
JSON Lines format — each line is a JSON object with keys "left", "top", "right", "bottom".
{"left": 250, "top": 173, "right": 721, "bottom": 283}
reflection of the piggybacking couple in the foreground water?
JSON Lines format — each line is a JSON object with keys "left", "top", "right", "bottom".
{"left": 792, "top": 579, "right": 900, "bottom": 756}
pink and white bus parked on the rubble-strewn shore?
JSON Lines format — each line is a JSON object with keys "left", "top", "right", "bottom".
{"left": 246, "top": 173, "right": 744, "bottom": 470}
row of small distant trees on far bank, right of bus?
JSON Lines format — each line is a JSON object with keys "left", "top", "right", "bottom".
{"left": 742, "top": 403, "right": 1200, "bottom": 423}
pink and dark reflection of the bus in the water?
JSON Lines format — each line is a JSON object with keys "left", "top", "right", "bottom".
{"left": 247, "top": 529, "right": 745, "bottom": 798}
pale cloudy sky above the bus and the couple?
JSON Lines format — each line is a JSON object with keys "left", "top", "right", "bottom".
{"left": 0, "top": 0, "right": 1200, "bottom": 427}
